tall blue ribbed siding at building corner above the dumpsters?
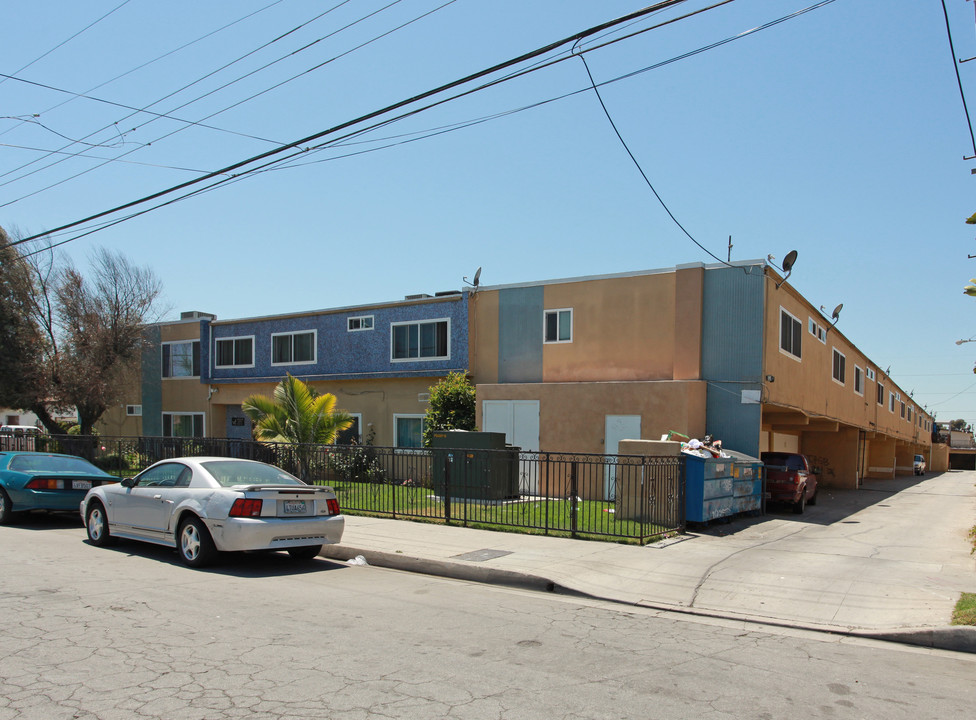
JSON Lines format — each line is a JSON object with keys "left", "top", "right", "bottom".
{"left": 702, "top": 266, "right": 765, "bottom": 457}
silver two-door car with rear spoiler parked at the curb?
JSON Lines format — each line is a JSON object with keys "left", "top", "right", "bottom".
{"left": 81, "top": 457, "right": 345, "bottom": 567}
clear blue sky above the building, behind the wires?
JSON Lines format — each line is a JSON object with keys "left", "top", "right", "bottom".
{"left": 0, "top": 0, "right": 976, "bottom": 422}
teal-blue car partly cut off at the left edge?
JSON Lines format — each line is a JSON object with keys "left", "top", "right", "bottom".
{"left": 0, "top": 452, "right": 118, "bottom": 525}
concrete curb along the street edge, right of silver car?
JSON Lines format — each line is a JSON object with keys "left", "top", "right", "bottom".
{"left": 319, "top": 545, "right": 976, "bottom": 653}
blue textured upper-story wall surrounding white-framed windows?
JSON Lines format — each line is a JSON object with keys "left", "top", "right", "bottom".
{"left": 201, "top": 294, "right": 468, "bottom": 382}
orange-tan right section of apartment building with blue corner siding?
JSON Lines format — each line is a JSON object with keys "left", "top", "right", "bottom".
{"left": 470, "top": 261, "right": 932, "bottom": 487}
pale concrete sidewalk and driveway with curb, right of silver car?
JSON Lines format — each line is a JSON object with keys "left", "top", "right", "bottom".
{"left": 322, "top": 471, "right": 976, "bottom": 652}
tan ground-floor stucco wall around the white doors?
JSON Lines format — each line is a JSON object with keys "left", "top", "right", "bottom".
{"left": 477, "top": 381, "right": 706, "bottom": 453}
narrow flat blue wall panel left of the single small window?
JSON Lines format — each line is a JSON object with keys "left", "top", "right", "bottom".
{"left": 498, "top": 287, "right": 545, "bottom": 383}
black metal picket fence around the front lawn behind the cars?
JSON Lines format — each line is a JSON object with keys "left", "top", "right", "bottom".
{"left": 0, "top": 436, "right": 684, "bottom": 543}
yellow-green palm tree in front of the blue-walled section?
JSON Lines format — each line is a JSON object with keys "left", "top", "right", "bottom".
{"left": 241, "top": 373, "right": 353, "bottom": 480}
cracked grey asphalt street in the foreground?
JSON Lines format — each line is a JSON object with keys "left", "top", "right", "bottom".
{"left": 0, "top": 519, "right": 976, "bottom": 720}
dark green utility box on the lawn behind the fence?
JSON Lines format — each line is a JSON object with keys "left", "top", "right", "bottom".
{"left": 430, "top": 430, "right": 519, "bottom": 500}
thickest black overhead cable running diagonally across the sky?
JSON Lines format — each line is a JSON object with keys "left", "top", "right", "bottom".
{"left": 11, "top": 0, "right": 685, "bottom": 245}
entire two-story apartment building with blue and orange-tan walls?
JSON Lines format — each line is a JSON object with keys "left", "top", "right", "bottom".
{"left": 103, "top": 261, "right": 932, "bottom": 487}
